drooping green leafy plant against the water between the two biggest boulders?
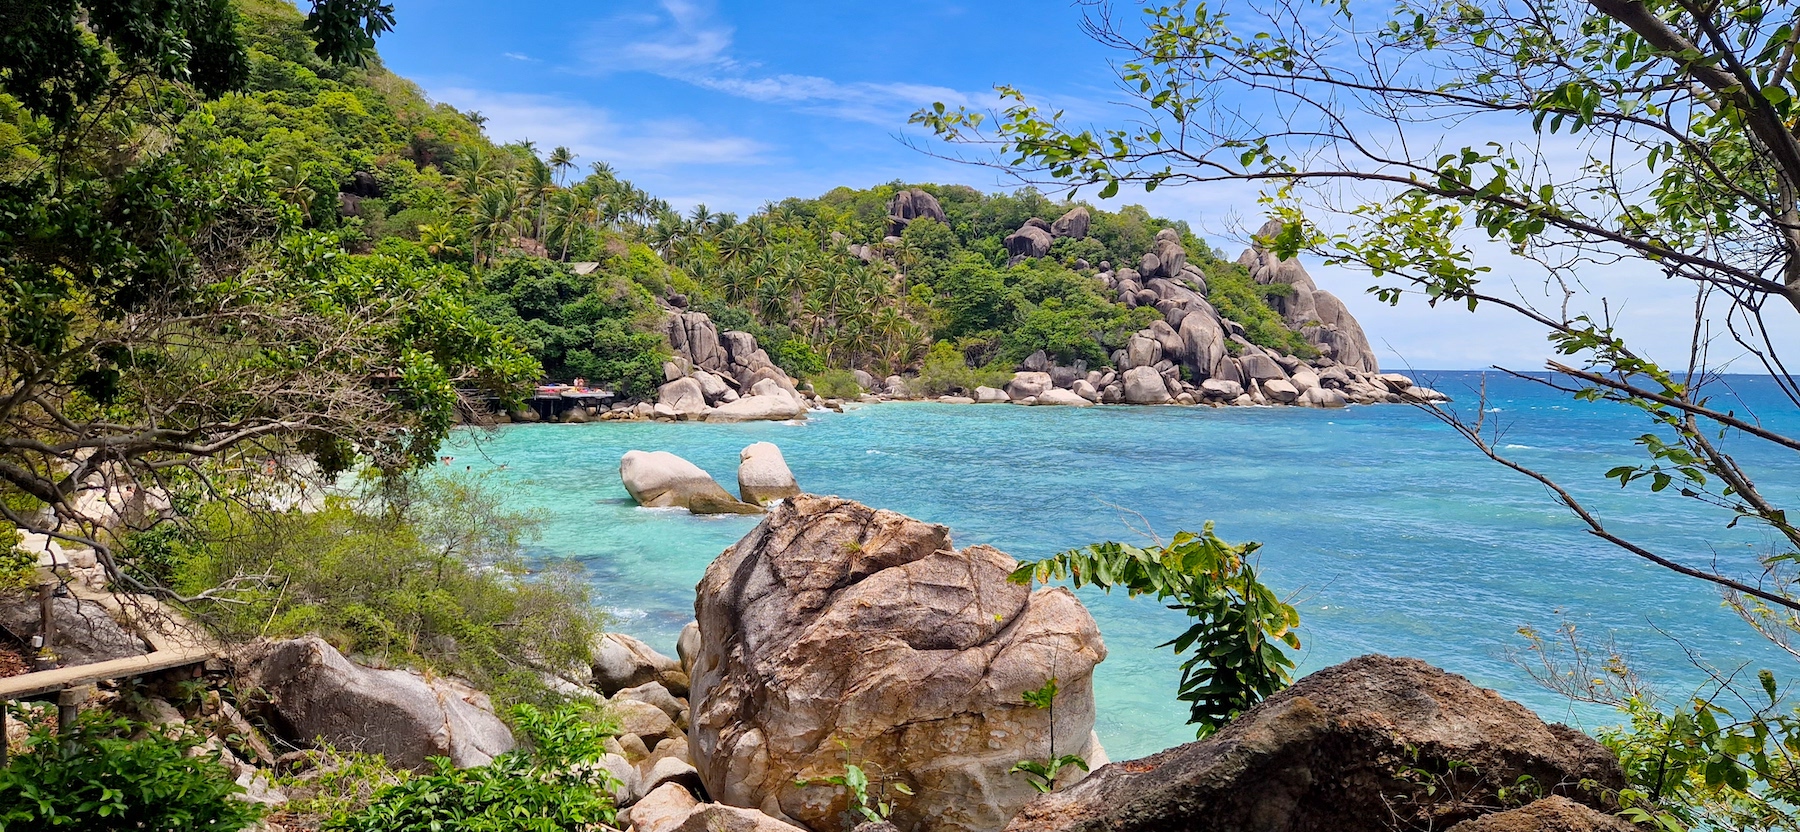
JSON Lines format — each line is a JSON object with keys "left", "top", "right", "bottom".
{"left": 1012, "top": 522, "right": 1300, "bottom": 737}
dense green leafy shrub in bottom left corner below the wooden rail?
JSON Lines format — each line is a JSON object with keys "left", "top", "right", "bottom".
{"left": 0, "top": 711, "right": 263, "bottom": 832}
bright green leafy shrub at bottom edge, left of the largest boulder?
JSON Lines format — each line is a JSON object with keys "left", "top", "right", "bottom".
{"left": 326, "top": 706, "right": 619, "bottom": 832}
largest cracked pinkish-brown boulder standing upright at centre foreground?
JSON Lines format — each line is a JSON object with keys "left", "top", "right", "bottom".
{"left": 689, "top": 495, "right": 1105, "bottom": 832}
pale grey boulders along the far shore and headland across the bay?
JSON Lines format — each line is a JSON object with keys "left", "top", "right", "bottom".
{"left": 513, "top": 208, "right": 1449, "bottom": 423}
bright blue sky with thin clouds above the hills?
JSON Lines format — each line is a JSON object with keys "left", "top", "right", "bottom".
{"left": 380, "top": 0, "right": 1748, "bottom": 369}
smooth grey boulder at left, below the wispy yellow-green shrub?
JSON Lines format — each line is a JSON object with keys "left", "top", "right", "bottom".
{"left": 234, "top": 636, "right": 513, "bottom": 771}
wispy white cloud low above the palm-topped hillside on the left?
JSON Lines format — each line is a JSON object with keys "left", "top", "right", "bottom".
{"left": 432, "top": 86, "right": 769, "bottom": 171}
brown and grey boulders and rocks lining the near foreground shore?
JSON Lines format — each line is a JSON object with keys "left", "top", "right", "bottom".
{"left": 3, "top": 489, "right": 1634, "bottom": 832}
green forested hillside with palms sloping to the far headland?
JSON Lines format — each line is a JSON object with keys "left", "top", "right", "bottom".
{"left": 191, "top": 0, "right": 1353, "bottom": 398}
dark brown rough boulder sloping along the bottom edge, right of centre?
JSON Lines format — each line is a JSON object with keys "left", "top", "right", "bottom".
{"left": 1006, "top": 656, "right": 1625, "bottom": 832}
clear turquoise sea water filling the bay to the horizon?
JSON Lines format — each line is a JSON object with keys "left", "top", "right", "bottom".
{"left": 445, "top": 373, "right": 1800, "bottom": 758}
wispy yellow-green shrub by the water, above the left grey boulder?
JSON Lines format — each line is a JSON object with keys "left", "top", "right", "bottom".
{"left": 176, "top": 475, "right": 598, "bottom": 702}
